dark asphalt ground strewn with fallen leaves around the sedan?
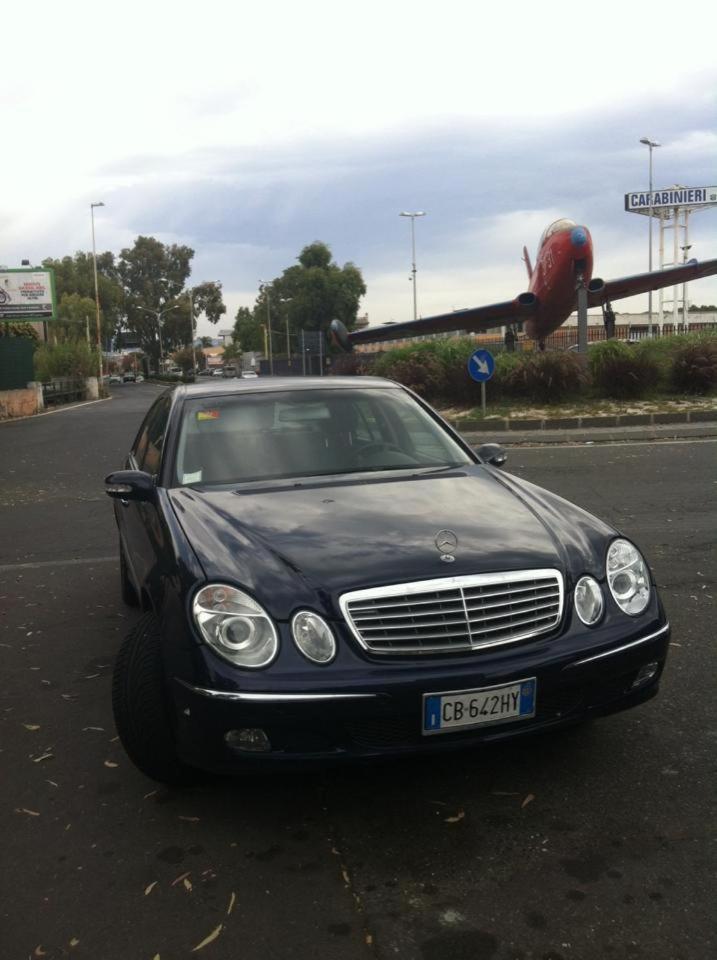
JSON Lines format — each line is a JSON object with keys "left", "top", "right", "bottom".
{"left": 0, "top": 384, "right": 717, "bottom": 960}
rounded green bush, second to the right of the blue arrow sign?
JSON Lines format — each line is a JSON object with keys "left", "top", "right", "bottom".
{"left": 588, "top": 340, "right": 662, "bottom": 400}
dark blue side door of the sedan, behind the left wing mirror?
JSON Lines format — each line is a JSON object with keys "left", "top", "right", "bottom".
{"left": 117, "top": 394, "right": 172, "bottom": 592}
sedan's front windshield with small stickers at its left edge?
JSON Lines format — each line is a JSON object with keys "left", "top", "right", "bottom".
{"left": 175, "top": 389, "right": 473, "bottom": 485}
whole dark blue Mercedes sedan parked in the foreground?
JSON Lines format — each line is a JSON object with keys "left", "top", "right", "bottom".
{"left": 106, "top": 377, "right": 670, "bottom": 783}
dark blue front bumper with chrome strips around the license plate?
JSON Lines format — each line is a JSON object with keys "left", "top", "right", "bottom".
{"left": 171, "top": 623, "right": 670, "bottom": 772}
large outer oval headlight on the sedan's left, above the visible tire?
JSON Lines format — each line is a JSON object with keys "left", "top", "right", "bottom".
{"left": 192, "top": 583, "right": 279, "bottom": 669}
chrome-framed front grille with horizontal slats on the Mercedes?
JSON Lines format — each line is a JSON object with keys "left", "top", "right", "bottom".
{"left": 340, "top": 570, "right": 563, "bottom": 655}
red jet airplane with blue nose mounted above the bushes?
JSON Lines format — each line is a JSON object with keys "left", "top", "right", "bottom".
{"left": 332, "top": 220, "right": 717, "bottom": 350}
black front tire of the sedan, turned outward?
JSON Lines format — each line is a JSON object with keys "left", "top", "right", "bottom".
{"left": 112, "top": 613, "right": 197, "bottom": 786}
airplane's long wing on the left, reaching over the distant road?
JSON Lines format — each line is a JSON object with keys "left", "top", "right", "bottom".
{"left": 348, "top": 293, "right": 538, "bottom": 344}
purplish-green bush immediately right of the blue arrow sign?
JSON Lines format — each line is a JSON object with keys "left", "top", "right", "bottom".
{"left": 500, "top": 351, "right": 590, "bottom": 403}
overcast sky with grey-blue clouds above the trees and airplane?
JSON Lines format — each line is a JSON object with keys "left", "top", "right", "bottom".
{"left": 0, "top": 0, "right": 717, "bottom": 332}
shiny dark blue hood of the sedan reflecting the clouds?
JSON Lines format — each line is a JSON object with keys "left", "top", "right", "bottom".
{"left": 170, "top": 465, "right": 607, "bottom": 619}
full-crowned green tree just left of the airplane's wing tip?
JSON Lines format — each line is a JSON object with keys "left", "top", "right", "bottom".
{"left": 254, "top": 240, "right": 366, "bottom": 349}
